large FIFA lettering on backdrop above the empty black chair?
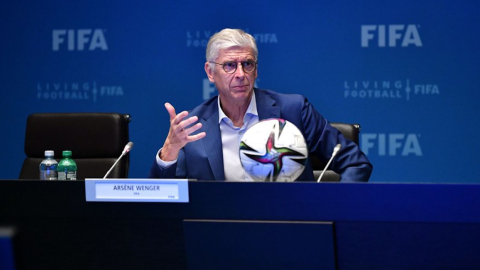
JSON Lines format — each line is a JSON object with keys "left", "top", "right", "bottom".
{"left": 52, "top": 29, "right": 108, "bottom": 51}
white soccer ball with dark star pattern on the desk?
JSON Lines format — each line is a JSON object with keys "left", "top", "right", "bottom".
{"left": 239, "top": 119, "right": 308, "bottom": 182}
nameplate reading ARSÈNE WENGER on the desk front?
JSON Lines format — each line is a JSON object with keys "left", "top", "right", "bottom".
{"left": 85, "top": 178, "right": 189, "bottom": 203}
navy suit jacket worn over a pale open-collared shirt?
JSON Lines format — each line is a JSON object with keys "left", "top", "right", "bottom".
{"left": 149, "top": 88, "right": 372, "bottom": 182}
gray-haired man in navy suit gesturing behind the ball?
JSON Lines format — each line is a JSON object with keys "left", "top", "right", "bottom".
{"left": 150, "top": 29, "right": 372, "bottom": 182}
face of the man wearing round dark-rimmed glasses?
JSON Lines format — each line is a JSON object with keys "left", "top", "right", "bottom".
{"left": 205, "top": 47, "right": 257, "bottom": 104}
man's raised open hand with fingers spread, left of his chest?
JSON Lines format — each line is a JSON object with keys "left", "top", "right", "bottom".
{"left": 160, "top": 102, "right": 206, "bottom": 161}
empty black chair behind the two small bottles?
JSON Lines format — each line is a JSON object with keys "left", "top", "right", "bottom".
{"left": 19, "top": 113, "right": 131, "bottom": 180}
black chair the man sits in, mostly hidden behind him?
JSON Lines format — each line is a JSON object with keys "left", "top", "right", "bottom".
{"left": 310, "top": 123, "right": 361, "bottom": 182}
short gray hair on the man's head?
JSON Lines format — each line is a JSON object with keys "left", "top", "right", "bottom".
{"left": 206, "top": 28, "right": 258, "bottom": 62}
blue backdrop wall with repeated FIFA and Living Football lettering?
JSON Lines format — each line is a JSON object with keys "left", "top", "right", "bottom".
{"left": 0, "top": 0, "right": 480, "bottom": 182}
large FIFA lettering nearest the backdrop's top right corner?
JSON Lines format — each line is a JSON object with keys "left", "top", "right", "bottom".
{"left": 361, "top": 24, "right": 422, "bottom": 47}
